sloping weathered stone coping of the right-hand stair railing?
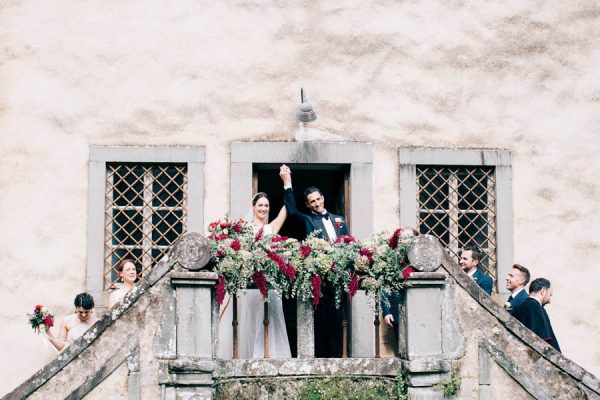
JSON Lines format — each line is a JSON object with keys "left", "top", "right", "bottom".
{"left": 440, "top": 254, "right": 600, "bottom": 396}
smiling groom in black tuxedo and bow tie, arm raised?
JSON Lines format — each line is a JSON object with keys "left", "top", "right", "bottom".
{"left": 279, "top": 164, "right": 348, "bottom": 358}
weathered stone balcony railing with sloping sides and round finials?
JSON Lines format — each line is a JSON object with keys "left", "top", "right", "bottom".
{"left": 5, "top": 233, "right": 600, "bottom": 400}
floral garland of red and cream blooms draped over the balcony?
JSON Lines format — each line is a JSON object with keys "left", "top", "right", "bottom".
{"left": 208, "top": 219, "right": 414, "bottom": 308}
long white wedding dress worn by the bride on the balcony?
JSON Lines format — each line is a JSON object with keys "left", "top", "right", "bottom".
{"left": 238, "top": 225, "right": 292, "bottom": 358}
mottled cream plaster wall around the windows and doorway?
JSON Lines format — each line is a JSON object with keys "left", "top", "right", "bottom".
{"left": 0, "top": 0, "right": 600, "bottom": 393}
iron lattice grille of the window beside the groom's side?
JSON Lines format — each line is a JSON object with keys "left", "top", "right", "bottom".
{"left": 417, "top": 166, "right": 497, "bottom": 281}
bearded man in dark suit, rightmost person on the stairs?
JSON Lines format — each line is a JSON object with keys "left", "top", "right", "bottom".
{"left": 513, "top": 278, "right": 560, "bottom": 351}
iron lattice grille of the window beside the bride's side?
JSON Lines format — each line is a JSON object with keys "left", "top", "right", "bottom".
{"left": 104, "top": 163, "right": 188, "bottom": 290}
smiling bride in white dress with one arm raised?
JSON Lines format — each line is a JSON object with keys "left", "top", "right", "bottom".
{"left": 239, "top": 192, "right": 291, "bottom": 358}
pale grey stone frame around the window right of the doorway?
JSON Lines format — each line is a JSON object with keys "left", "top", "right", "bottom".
{"left": 398, "top": 148, "right": 513, "bottom": 294}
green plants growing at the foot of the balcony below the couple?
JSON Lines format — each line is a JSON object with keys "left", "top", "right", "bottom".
{"left": 298, "top": 378, "right": 402, "bottom": 400}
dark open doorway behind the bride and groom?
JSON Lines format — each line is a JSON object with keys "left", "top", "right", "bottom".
{"left": 252, "top": 163, "right": 351, "bottom": 357}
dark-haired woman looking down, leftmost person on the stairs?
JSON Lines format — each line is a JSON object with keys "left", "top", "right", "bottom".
{"left": 46, "top": 292, "right": 98, "bottom": 351}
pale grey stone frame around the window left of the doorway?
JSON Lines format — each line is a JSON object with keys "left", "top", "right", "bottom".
{"left": 86, "top": 146, "right": 204, "bottom": 307}
